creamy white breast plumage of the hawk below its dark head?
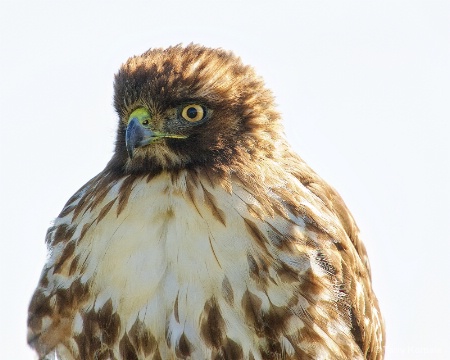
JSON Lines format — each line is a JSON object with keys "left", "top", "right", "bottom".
{"left": 50, "top": 171, "right": 309, "bottom": 357}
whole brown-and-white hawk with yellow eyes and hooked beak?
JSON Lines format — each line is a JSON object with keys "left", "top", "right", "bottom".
{"left": 28, "top": 44, "right": 385, "bottom": 360}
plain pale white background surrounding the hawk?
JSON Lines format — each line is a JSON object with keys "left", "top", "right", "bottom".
{"left": 0, "top": 0, "right": 450, "bottom": 359}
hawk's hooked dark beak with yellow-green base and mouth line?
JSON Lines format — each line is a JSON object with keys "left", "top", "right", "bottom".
{"left": 125, "top": 117, "right": 187, "bottom": 159}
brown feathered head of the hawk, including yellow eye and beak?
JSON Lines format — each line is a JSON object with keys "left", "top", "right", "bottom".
{"left": 109, "top": 44, "right": 282, "bottom": 174}
